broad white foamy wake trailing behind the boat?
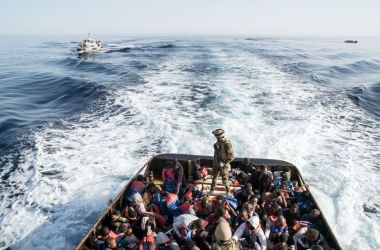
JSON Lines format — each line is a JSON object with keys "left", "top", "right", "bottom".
{"left": 0, "top": 38, "right": 380, "bottom": 249}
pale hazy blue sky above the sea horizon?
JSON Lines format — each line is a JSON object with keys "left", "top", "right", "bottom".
{"left": 0, "top": 0, "right": 380, "bottom": 38}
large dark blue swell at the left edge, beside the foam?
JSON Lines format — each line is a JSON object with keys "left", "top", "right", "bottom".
{"left": 0, "top": 73, "right": 105, "bottom": 141}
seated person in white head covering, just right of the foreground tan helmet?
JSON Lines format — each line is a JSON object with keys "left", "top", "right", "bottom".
{"left": 232, "top": 216, "right": 267, "bottom": 250}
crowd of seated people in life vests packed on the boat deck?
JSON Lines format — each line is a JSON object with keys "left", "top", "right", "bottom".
{"left": 86, "top": 159, "right": 329, "bottom": 250}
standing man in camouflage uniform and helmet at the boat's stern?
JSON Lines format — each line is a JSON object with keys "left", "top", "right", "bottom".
{"left": 210, "top": 128, "right": 235, "bottom": 194}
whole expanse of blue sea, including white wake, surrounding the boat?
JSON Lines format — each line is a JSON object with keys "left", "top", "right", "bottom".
{"left": 0, "top": 36, "right": 380, "bottom": 249}
